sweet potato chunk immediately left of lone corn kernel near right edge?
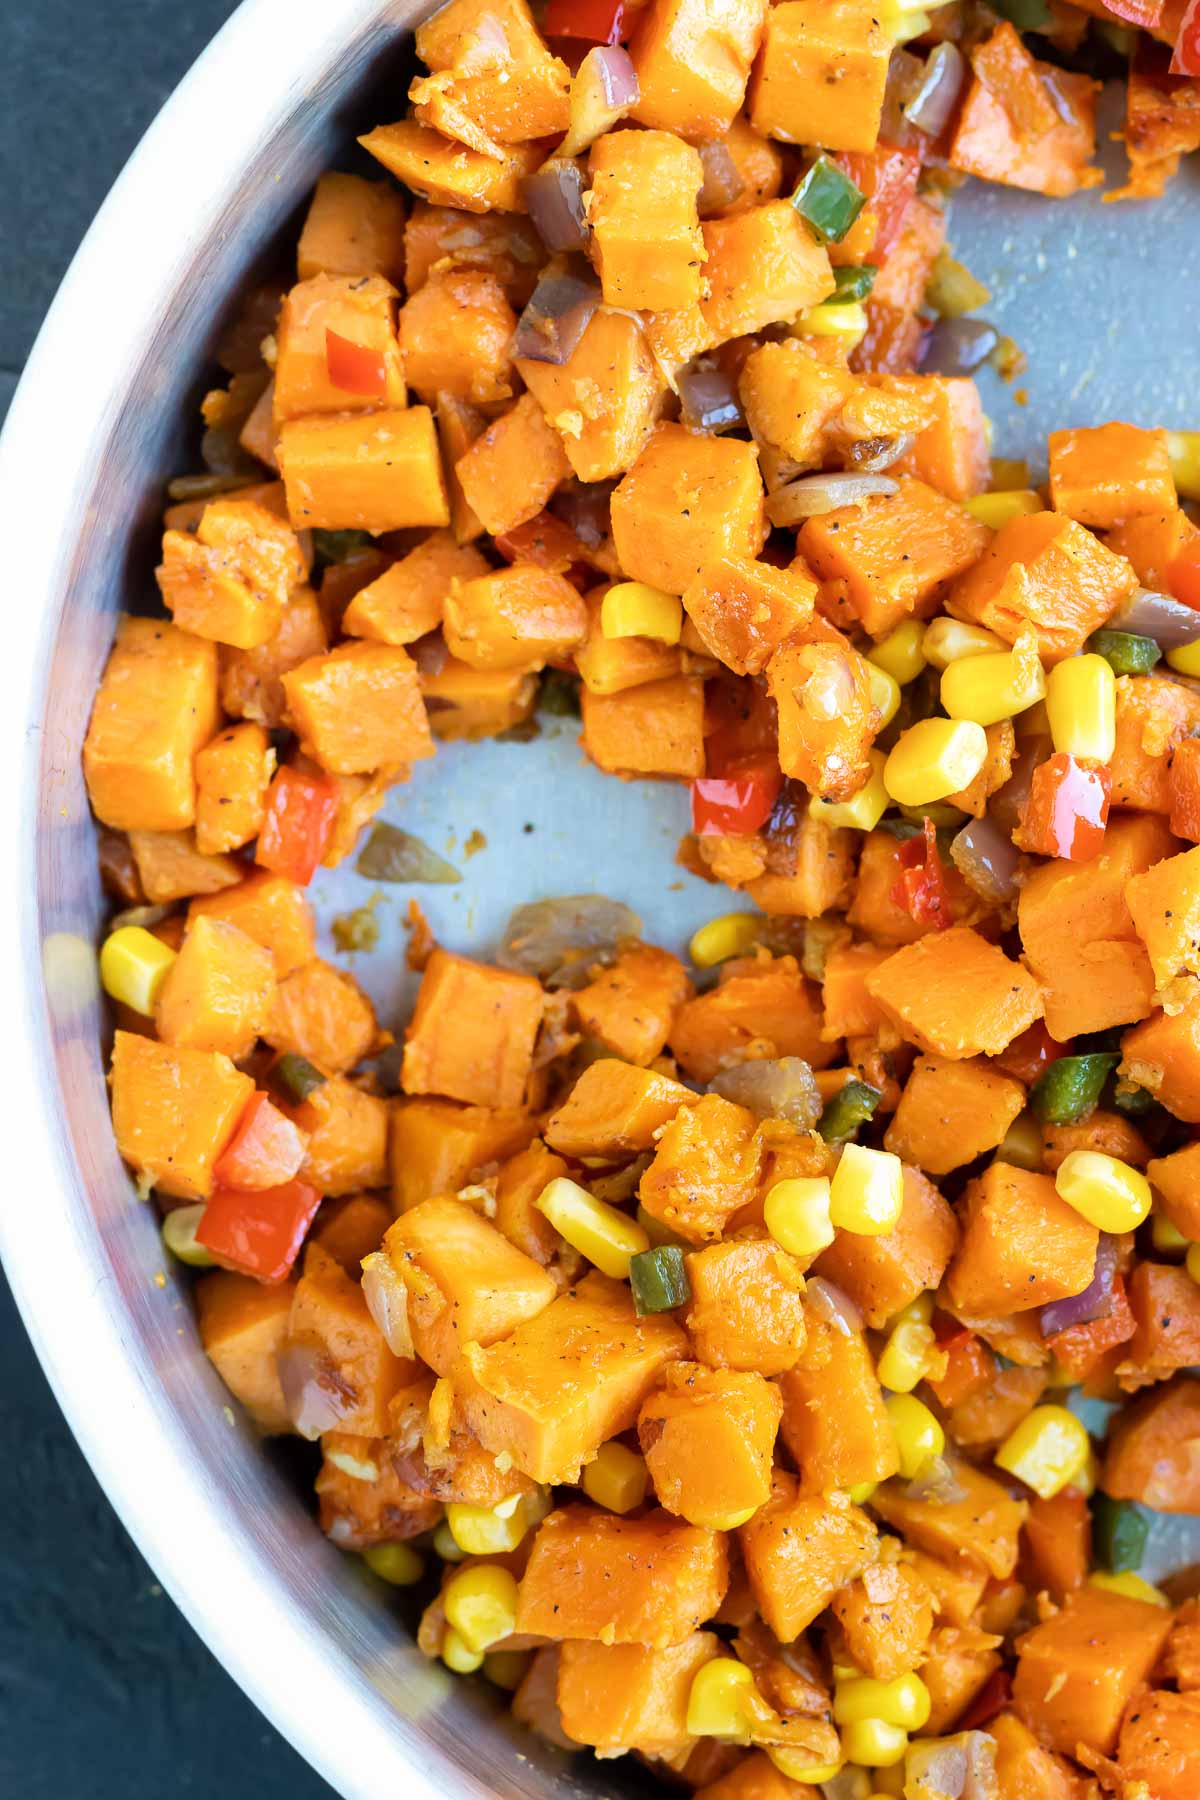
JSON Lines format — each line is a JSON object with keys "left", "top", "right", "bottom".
{"left": 946, "top": 1163, "right": 1099, "bottom": 1318}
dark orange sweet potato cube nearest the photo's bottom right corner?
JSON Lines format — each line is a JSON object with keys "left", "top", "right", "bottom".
{"left": 1013, "top": 1584, "right": 1171, "bottom": 1757}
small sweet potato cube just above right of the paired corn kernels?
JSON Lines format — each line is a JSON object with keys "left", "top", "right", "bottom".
{"left": 883, "top": 1057, "right": 1025, "bottom": 1175}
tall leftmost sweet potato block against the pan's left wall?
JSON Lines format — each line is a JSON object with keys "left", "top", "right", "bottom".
{"left": 83, "top": 617, "right": 221, "bottom": 832}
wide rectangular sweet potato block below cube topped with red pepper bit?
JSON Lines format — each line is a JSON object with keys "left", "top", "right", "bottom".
{"left": 279, "top": 407, "right": 450, "bottom": 531}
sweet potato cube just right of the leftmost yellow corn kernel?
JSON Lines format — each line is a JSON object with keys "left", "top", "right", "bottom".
{"left": 155, "top": 914, "right": 275, "bottom": 1062}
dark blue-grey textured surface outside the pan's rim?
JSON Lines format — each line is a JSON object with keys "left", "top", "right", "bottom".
{"left": 0, "top": 0, "right": 331, "bottom": 1800}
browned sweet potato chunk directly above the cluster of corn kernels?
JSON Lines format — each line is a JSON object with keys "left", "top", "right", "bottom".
{"left": 946, "top": 513, "right": 1137, "bottom": 662}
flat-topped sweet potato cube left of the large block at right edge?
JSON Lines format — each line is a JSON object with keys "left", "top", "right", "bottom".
{"left": 867, "top": 925, "right": 1042, "bottom": 1062}
